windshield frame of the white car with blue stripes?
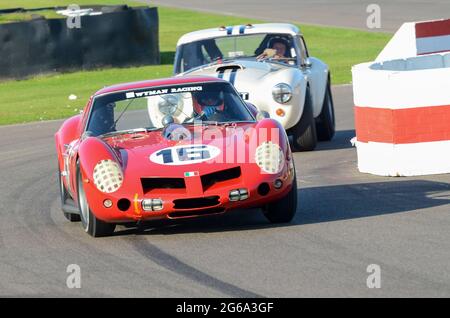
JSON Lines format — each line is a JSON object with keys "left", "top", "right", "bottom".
{"left": 173, "top": 32, "right": 302, "bottom": 75}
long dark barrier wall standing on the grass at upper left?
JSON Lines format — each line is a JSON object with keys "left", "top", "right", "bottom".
{"left": 0, "top": 6, "right": 160, "bottom": 79}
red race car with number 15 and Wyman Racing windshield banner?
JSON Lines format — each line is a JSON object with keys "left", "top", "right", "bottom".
{"left": 55, "top": 77, "right": 297, "bottom": 237}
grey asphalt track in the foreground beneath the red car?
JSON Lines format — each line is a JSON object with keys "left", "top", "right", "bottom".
{"left": 0, "top": 86, "right": 450, "bottom": 297}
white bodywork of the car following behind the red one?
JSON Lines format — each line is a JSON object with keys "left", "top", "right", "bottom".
{"left": 175, "top": 23, "right": 329, "bottom": 129}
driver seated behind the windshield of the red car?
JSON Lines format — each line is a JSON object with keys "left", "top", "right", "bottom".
{"left": 194, "top": 92, "right": 225, "bottom": 121}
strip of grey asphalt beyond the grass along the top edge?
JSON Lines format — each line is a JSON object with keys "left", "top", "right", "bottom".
{"left": 148, "top": 0, "right": 450, "bottom": 32}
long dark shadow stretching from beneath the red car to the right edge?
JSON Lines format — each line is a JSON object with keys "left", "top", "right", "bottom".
{"left": 115, "top": 180, "right": 450, "bottom": 236}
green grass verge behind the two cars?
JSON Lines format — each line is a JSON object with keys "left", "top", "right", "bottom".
{"left": 0, "top": 0, "right": 391, "bottom": 125}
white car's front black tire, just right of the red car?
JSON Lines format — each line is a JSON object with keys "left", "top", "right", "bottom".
{"left": 291, "top": 88, "right": 317, "bottom": 151}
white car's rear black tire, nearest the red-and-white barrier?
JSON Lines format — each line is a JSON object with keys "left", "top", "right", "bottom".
{"left": 316, "top": 81, "right": 336, "bottom": 141}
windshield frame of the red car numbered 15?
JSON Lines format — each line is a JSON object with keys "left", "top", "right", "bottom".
{"left": 82, "top": 79, "right": 257, "bottom": 137}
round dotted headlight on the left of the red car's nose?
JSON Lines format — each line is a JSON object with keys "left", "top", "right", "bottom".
{"left": 94, "top": 159, "right": 123, "bottom": 193}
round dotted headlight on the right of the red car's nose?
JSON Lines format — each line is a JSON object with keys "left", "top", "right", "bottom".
{"left": 255, "top": 141, "right": 284, "bottom": 174}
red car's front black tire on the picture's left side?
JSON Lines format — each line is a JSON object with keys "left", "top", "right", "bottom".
{"left": 77, "top": 166, "right": 116, "bottom": 237}
